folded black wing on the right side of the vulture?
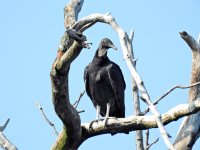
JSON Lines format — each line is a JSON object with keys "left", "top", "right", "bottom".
{"left": 107, "top": 63, "right": 126, "bottom": 115}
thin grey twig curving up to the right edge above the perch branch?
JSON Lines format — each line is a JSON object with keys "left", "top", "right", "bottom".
{"left": 140, "top": 82, "right": 200, "bottom": 115}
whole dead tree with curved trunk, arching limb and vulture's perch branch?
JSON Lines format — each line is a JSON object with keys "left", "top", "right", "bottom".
{"left": 50, "top": 0, "right": 200, "bottom": 150}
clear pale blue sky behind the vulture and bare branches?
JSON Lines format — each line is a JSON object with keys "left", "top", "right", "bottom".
{"left": 0, "top": 0, "right": 200, "bottom": 150}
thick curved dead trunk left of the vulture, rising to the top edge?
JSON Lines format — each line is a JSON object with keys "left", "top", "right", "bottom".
{"left": 50, "top": 0, "right": 83, "bottom": 150}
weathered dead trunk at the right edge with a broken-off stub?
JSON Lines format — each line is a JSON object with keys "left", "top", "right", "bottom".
{"left": 174, "top": 31, "right": 200, "bottom": 150}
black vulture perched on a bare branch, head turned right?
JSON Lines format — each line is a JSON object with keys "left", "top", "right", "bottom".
{"left": 84, "top": 38, "right": 126, "bottom": 125}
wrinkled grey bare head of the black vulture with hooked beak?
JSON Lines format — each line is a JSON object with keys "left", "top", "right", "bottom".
{"left": 98, "top": 38, "right": 117, "bottom": 57}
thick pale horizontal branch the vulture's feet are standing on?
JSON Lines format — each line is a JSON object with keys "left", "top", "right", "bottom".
{"left": 82, "top": 100, "right": 200, "bottom": 142}
